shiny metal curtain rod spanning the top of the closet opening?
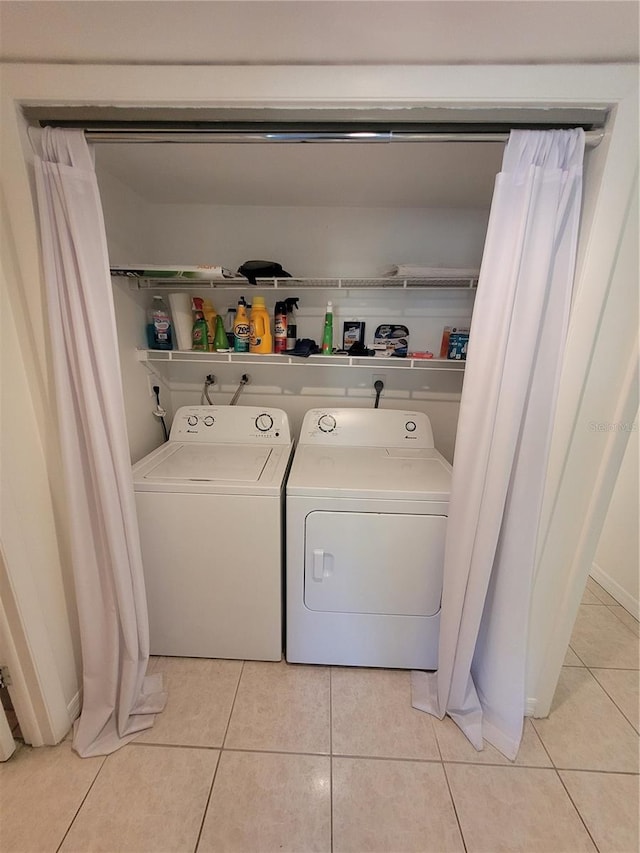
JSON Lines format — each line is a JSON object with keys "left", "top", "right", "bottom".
{"left": 85, "top": 129, "right": 604, "bottom": 148}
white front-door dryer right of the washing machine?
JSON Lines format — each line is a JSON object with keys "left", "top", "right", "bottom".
{"left": 286, "top": 408, "right": 452, "bottom": 669}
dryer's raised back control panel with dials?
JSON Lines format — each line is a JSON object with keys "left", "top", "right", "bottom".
{"left": 299, "top": 408, "right": 434, "bottom": 449}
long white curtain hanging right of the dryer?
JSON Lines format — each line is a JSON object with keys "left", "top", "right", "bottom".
{"left": 412, "top": 129, "right": 584, "bottom": 759}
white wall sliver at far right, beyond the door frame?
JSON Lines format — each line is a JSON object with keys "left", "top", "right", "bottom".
{"left": 591, "top": 413, "right": 640, "bottom": 619}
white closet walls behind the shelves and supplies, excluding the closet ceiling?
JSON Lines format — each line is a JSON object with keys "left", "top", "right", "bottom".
{"left": 97, "top": 185, "right": 490, "bottom": 462}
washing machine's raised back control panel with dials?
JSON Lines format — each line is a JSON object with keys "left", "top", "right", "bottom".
{"left": 169, "top": 406, "right": 291, "bottom": 444}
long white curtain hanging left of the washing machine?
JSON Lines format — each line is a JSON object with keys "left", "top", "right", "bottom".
{"left": 36, "top": 128, "right": 166, "bottom": 756}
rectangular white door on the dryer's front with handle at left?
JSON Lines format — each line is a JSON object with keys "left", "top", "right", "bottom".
{"left": 304, "top": 510, "right": 447, "bottom": 616}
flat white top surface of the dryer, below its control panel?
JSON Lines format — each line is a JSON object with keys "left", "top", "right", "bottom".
{"left": 287, "top": 445, "right": 452, "bottom": 501}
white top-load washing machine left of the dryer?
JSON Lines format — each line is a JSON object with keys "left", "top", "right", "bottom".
{"left": 133, "top": 406, "right": 293, "bottom": 660}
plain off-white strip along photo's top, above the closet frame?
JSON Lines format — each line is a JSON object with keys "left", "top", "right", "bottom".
{"left": 0, "top": 0, "right": 639, "bottom": 65}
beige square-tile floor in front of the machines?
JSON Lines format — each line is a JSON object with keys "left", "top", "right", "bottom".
{"left": 0, "top": 580, "right": 640, "bottom": 853}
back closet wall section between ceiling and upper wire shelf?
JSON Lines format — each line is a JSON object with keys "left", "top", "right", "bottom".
{"left": 142, "top": 202, "right": 491, "bottom": 277}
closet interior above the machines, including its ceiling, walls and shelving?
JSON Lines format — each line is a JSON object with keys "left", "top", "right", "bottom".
{"left": 96, "top": 129, "right": 504, "bottom": 462}
